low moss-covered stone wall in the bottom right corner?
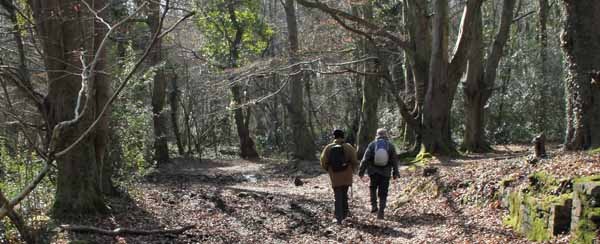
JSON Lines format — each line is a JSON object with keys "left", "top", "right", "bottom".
{"left": 499, "top": 173, "right": 600, "bottom": 243}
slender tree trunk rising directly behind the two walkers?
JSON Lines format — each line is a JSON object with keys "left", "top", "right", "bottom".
{"left": 356, "top": 5, "right": 381, "bottom": 158}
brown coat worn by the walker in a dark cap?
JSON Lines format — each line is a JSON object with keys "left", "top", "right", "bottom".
{"left": 321, "top": 139, "right": 358, "bottom": 187}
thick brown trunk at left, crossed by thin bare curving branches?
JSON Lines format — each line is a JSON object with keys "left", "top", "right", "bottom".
{"left": 29, "top": 0, "right": 109, "bottom": 215}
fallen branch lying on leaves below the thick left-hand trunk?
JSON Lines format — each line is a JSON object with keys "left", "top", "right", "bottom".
{"left": 60, "top": 225, "right": 196, "bottom": 236}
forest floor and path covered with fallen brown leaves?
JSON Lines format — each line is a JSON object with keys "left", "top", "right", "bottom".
{"left": 52, "top": 146, "right": 600, "bottom": 243}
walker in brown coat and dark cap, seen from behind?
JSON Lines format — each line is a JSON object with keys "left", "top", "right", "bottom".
{"left": 321, "top": 129, "right": 358, "bottom": 224}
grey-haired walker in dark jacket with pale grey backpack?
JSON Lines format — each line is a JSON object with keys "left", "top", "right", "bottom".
{"left": 358, "top": 128, "right": 400, "bottom": 219}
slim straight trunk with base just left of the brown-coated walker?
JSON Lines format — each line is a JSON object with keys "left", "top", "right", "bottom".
{"left": 284, "top": 0, "right": 316, "bottom": 160}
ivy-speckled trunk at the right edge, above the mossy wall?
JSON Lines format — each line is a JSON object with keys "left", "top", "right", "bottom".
{"left": 562, "top": 0, "right": 600, "bottom": 150}
